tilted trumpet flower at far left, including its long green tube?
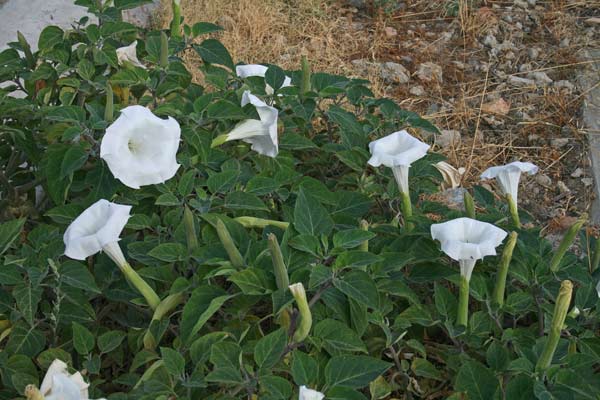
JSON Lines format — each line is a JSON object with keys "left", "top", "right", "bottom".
{"left": 63, "top": 199, "right": 160, "bottom": 310}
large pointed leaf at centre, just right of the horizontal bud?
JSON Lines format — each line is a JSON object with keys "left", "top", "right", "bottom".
{"left": 294, "top": 188, "right": 333, "bottom": 236}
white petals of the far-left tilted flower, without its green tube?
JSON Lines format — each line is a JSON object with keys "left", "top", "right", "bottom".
{"left": 63, "top": 199, "right": 131, "bottom": 260}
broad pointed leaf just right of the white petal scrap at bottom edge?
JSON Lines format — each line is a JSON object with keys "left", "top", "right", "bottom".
{"left": 325, "top": 356, "right": 391, "bottom": 389}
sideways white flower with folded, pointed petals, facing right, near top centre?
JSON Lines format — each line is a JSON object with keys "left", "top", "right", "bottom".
{"left": 212, "top": 90, "right": 279, "bottom": 157}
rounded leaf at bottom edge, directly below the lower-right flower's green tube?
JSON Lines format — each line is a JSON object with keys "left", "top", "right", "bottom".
{"left": 454, "top": 360, "right": 498, "bottom": 400}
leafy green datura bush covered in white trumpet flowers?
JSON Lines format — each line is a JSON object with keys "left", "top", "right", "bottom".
{"left": 0, "top": 0, "right": 600, "bottom": 400}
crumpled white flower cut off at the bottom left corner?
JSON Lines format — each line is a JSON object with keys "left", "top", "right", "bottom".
{"left": 25, "top": 359, "right": 103, "bottom": 400}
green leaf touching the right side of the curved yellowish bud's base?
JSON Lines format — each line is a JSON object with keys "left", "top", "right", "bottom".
{"left": 313, "top": 318, "right": 367, "bottom": 356}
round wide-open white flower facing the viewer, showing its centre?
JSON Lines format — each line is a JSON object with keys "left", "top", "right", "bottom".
{"left": 100, "top": 105, "right": 181, "bottom": 189}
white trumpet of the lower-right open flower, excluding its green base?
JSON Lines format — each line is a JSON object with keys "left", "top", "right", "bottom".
{"left": 431, "top": 218, "right": 506, "bottom": 280}
